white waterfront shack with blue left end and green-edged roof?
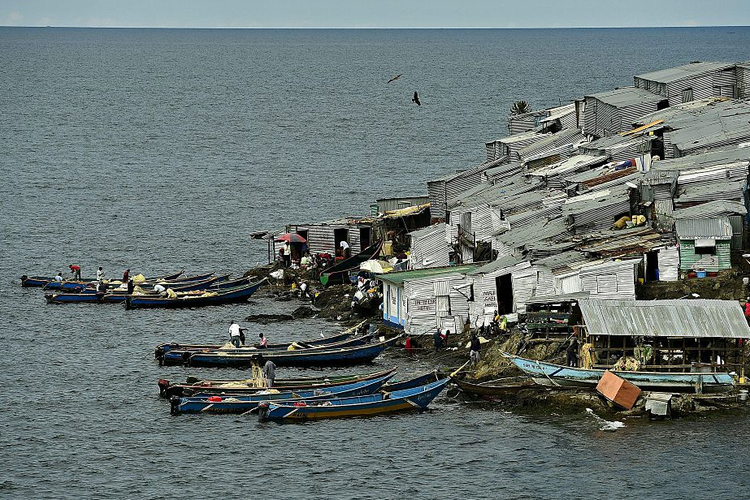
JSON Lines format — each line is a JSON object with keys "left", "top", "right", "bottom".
{"left": 377, "top": 264, "right": 479, "bottom": 335}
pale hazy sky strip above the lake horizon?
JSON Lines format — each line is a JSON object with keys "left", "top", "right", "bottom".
{"left": 0, "top": 0, "right": 750, "bottom": 28}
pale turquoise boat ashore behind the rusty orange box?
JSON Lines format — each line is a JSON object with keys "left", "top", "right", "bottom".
{"left": 503, "top": 353, "right": 734, "bottom": 392}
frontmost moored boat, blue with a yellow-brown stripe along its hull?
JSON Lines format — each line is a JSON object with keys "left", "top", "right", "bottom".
{"left": 258, "top": 377, "right": 450, "bottom": 421}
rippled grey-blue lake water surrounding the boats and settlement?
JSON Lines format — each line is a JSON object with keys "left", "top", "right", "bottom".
{"left": 0, "top": 28, "right": 750, "bottom": 499}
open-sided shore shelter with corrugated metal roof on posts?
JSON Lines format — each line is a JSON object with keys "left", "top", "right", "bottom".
{"left": 578, "top": 299, "right": 750, "bottom": 372}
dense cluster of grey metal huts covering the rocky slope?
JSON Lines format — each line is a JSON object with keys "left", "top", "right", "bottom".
{"left": 288, "top": 62, "right": 750, "bottom": 344}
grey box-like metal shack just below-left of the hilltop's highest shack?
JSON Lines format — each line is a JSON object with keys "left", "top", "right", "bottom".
{"left": 583, "top": 87, "right": 667, "bottom": 137}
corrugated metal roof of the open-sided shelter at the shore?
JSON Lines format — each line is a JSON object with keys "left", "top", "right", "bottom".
{"left": 578, "top": 299, "right": 750, "bottom": 338}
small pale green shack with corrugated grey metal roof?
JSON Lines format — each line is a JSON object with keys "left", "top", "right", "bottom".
{"left": 675, "top": 217, "right": 732, "bottom": 272}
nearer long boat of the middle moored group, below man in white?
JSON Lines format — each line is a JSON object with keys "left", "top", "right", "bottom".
{"left": 187, "top": 334, "right": 403, "bottom": 367}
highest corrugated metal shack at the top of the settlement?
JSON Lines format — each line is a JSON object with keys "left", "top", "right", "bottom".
{"left": 634, "top": 62, "right": 738, "bottom": 106}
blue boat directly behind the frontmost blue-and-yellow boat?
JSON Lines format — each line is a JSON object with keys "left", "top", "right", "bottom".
{"left": 170, "top": 368, "right": 396, "bottom": 415}
